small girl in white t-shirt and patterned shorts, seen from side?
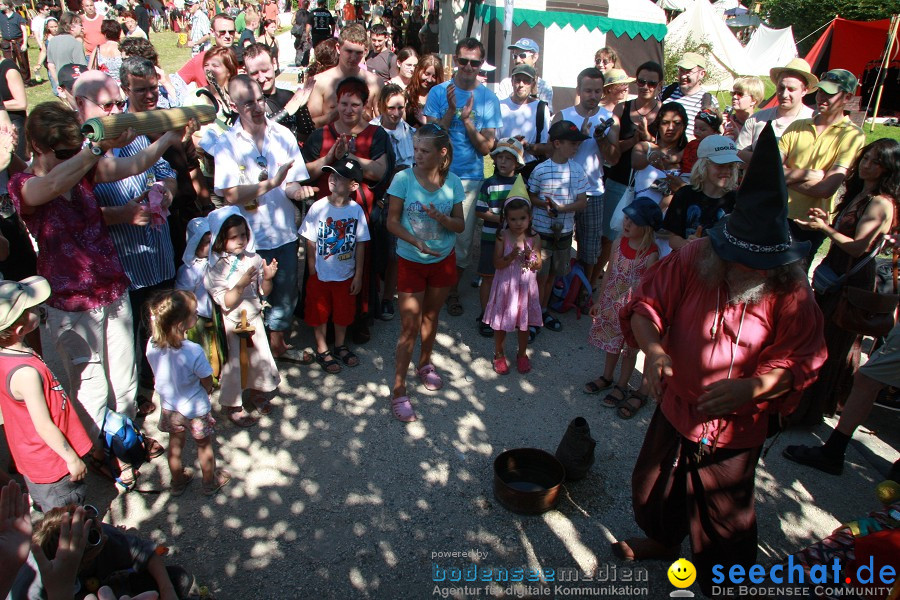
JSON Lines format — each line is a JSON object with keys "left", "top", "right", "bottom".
{"left": 147, "top": 290, "right": 231, "bottom": 496}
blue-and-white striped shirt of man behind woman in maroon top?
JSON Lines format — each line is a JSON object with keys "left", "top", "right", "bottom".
{"left": 94, "top": 135, "right": 176, "bottom": 290}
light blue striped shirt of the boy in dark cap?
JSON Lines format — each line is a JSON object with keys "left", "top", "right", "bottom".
{"left": 528, "top": 158, "right": 590, "bottom": 235}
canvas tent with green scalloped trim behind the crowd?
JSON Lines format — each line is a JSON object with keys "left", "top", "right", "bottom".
{"left": 464, "top": 0, "right": 666, "bottom": 107}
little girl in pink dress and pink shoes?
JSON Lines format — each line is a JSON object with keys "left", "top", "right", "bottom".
{"left": 484, "top": 196, "right": 542, "bottom": 375}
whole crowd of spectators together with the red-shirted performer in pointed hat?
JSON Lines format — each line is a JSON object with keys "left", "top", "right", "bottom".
{"left": 0, "top": 0, "right": 900, "bottom": 597}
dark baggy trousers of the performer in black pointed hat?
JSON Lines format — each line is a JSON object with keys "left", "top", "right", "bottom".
{"left": 631, "top": 408, "right": 762, "bottom": 596}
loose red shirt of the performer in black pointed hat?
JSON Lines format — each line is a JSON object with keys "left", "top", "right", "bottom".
{"left": 619, "top": 238, "right": 827, "bottom": 449}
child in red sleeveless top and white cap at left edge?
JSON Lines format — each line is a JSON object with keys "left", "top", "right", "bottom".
{"left": 0, "top": 276, "right": 91, "bottom": 512}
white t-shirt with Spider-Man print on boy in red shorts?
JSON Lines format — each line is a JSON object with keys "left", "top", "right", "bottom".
{"left": 300, "top": 198, "right": 370, "bottom": 281}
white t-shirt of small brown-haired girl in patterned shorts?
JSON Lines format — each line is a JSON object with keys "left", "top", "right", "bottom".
{"left": 147, "top": 340, "right": 212, "bottom": 419}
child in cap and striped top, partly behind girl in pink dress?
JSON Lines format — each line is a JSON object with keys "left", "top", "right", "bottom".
{"left": 475, "top": 138, "right": 540, "bottom": 337}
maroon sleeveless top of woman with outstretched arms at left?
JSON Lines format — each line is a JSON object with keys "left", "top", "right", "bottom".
{"left": 9, "top": 173, "right": 129, "bottom": 312}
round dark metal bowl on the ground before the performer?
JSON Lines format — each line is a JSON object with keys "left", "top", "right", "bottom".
{"left": 494, "top": 448, "right": 566, "bottom": 515}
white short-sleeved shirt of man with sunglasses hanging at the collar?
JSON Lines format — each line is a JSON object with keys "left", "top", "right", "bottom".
{"left": 213, "top": 120, "right": 309, "bottom": 250}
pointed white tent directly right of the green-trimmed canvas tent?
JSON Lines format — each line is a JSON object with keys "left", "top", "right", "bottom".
{"left": 666, "top": 0, "right": 754, "bottom": 90}
